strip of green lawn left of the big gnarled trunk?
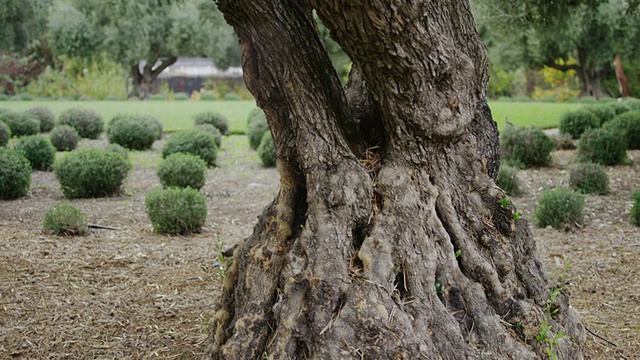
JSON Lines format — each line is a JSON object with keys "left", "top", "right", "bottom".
{"left": 0, "top": 100, "right": 256, "bottom": 132}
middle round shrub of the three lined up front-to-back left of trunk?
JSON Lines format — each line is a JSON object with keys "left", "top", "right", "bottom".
{"left": 156, "top": 153, "right": 207, "bottom": 190}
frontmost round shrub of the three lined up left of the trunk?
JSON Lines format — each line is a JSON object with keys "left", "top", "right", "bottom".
{"left": 145, "top": 188, "right": 207, "bottom": 235}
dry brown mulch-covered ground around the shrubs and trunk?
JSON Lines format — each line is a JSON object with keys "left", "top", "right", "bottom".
{"left": 0, "top": 137, "right": 640, "bottom": 360}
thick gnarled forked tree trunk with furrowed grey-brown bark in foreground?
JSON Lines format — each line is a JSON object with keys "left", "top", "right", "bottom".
{"left": 205, "top": 0, "right": 584, "bottom": 359}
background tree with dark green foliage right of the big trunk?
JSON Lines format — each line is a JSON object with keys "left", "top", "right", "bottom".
{"left": 475, "top": 0, "right": 639, "bottom": 98}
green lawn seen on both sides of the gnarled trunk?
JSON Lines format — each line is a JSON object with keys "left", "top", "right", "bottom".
{"left": 0, "top": 100, "right": 583, "bottom": 132}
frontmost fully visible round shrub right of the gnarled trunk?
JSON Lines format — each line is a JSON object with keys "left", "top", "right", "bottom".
{"left": 532, "top": 188, "right": 584, "bottom": 229}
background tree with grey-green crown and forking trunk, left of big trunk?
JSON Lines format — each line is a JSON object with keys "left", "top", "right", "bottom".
{"left": 48, "top": 0, "right": 240, "bottom": 98}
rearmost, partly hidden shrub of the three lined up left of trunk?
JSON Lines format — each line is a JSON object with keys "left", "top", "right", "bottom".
{"left": 162, "top": 130, "right": 218, "bottom": 166}
